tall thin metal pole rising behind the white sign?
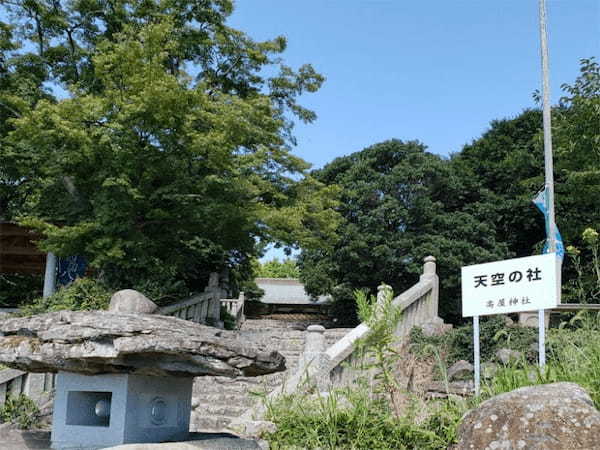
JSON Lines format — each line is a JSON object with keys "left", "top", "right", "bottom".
{"left": 540, "top": 0, "right": 556, "bottom": 252}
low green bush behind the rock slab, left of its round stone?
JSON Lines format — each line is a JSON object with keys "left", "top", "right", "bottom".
{"left": 21, "top": 278, "right": 112, "bottom": 315}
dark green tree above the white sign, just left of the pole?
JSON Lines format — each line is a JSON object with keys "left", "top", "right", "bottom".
{"left": 450, "top": 110, "right": 544, "bottom": 256}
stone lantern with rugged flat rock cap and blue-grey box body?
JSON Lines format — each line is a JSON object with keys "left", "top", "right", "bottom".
{"left": 0, "top": 311, "right": 285, "bottom": 450}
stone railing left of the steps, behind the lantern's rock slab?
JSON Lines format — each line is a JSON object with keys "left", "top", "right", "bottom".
{"left": 156, "top": 273, "right": 222, "bottom": 326}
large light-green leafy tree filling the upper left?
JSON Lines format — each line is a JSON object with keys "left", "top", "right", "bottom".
{"left": 0, "top": 0, "right": 336, "bottom": 296}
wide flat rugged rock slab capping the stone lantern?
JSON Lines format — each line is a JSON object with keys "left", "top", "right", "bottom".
{"left": 0, "top": 311, "right": 285, "bottom": 377}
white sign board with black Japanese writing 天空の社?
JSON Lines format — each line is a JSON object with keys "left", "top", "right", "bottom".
{"left": 461, "top": 253, "right": 559, "bottom": 317}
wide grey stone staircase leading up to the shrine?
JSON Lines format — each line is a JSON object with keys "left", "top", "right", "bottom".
{"left": 190, "top": 319, "right": 349, "bottom": 432}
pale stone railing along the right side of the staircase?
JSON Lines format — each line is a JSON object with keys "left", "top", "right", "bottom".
{"left": 234, "top": 256, "right": 443, "bottom": 429}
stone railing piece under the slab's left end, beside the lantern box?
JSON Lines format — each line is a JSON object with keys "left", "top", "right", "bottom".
{"left": 0, "top": 369, "right": 55, "bottom": 406}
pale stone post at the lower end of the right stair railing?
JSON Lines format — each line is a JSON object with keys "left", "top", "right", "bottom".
{"left": 300, "top": 325, "right": 329, "bottom": 392}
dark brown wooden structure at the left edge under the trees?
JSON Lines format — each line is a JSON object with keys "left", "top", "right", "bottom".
{"left": 0, "top": 222, "right": 46, "bottom": 275}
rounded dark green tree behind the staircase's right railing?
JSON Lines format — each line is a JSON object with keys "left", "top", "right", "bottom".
{"left": 299, "top": 140, "right": 507, "bottom": 321}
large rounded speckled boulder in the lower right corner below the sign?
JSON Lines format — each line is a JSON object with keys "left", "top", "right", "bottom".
{"left": 454, "top": 383, "right": 600, "bottom": 450}
